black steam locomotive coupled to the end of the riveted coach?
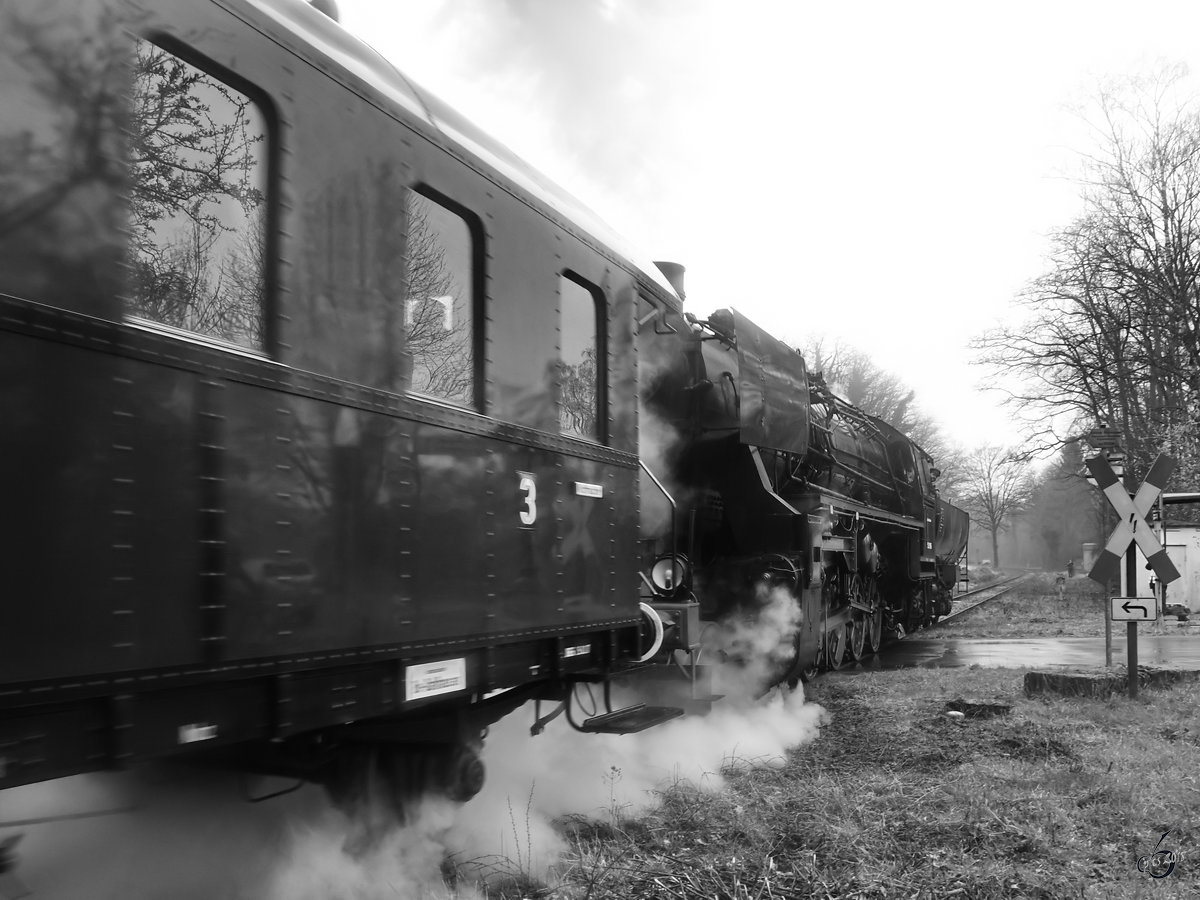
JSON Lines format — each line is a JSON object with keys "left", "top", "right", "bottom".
{"left": 638, "top": 303, "right": 967, "bottom": 692}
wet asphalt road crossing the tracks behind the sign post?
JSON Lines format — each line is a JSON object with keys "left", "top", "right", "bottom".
{"left": 842, "top": 624, "right": 1200, "bottom": 672}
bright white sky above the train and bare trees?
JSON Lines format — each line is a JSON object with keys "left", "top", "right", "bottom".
{"left": 340, "top": 0, "right": 1200, "bottom": 448}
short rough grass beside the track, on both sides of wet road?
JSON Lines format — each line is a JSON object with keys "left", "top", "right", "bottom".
{"left": 451, "top": 576, "right": 1200, "bottom": 900}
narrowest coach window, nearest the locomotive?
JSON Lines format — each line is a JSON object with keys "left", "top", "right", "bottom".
{"left": 558, "top": 272, "right": 604, "bottom": 440}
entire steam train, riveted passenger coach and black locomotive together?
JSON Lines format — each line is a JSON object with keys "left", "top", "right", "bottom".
{"left": 0, "top": 0, "right": 966, "bottom": 830}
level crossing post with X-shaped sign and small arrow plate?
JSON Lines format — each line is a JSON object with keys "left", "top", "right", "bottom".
{"left": 1087, "top": 454, "right": 1180, "bottom": 698}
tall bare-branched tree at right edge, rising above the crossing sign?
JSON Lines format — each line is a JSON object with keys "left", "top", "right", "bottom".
{"left": 976, "top": 67, "right": 1200, "bottom": 486}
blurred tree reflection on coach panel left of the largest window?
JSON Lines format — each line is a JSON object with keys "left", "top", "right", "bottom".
{"left": 0, "top": 0, "right": 128, "bottom": 317}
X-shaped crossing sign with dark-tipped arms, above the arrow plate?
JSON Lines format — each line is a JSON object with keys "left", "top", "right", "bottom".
{"left": 1087, "top": 454, "right": 1180, "bottom": 584}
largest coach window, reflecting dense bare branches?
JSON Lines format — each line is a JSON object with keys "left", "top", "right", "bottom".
{"left": 126, "top": 40, "right": 268, "bottom": 349}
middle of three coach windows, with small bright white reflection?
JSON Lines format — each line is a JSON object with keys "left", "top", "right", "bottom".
{"left": 404, "top": 191, "right": 475, "bottom": 406}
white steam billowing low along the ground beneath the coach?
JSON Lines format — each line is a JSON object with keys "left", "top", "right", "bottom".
{"left": 0, "top": 589, "right": 824, "bottom": 900}
